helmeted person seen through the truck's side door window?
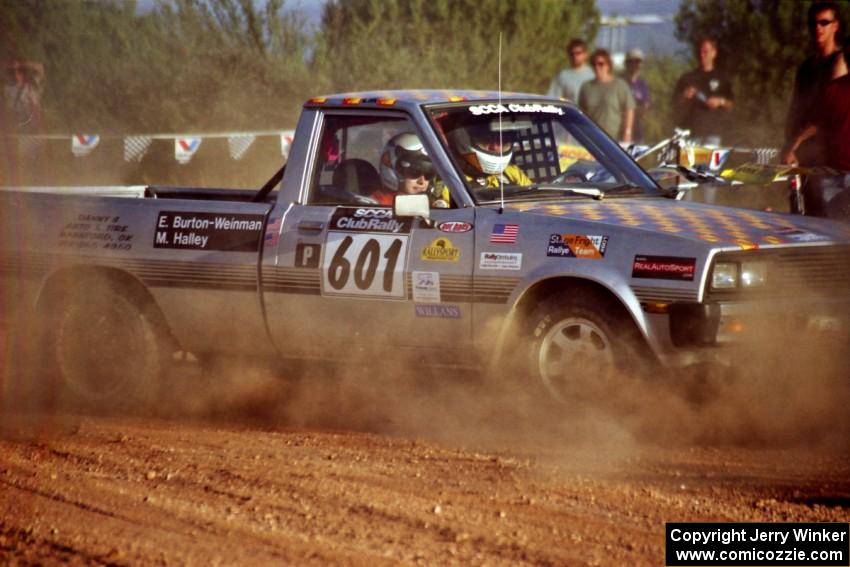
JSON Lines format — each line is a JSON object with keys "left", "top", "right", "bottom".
{"left": 369, "top": 132, "right": 450, "bottom": 209}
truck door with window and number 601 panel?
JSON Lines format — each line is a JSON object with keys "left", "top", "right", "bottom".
{"left": 263, "top": 111, "right": 474, "bottom": 355}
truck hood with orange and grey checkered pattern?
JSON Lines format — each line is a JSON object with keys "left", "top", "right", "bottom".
{"left": 505, "top": 199, "right": 850, "bottom": 249}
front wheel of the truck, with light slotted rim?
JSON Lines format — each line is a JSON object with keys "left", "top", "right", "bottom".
{"left": 528, "top": 290, "right": 640, "bottom": 405}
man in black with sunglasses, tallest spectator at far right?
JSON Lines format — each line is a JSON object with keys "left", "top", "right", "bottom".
{"left": 785, "top": 2, "right": 846, "bottom": 166}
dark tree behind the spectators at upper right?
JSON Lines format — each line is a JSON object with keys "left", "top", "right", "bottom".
{"left": 676, "top": 0, "right": 850, "bottom": 146}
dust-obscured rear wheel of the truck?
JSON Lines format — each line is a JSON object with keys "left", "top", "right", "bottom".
{"left": 46, "top": 281, "right": 169, "bottom": 411}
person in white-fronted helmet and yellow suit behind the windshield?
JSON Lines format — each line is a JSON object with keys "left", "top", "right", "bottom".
{"left": 454, "top": 121, "right": 532, "bottom": 188}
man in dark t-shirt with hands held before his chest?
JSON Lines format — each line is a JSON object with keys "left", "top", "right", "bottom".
{"left": 673, "top": 37, "right": 735, "bottom": 146}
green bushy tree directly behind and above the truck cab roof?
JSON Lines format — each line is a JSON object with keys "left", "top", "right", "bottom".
{"left": 314, "top": 0, "right": 599, "bottom": 92}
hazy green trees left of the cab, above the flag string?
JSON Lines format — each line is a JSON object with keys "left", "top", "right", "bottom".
{"left": 0, "top": 0, "right": 310, "bottom": 133}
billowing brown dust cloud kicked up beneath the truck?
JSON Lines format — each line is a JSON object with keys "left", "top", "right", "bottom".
{"left": 119, "top": 316, "right": 850, "bottom": 464}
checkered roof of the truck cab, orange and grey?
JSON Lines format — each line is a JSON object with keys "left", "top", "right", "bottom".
{"left": 304, "top": 89, "right": 565, "bottom": 108}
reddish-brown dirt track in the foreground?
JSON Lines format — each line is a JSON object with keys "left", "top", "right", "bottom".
{"left": 0, "top": 360, "right": 850, "bottom": 565}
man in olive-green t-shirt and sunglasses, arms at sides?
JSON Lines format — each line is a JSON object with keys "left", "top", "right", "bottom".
{"left": 578, "top": 49, "right": 635, "bottom": 142}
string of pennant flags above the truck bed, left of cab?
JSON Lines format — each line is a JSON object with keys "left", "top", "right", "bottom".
{"left": 12, "top": 130, "right": 295, "bottom": 164}
